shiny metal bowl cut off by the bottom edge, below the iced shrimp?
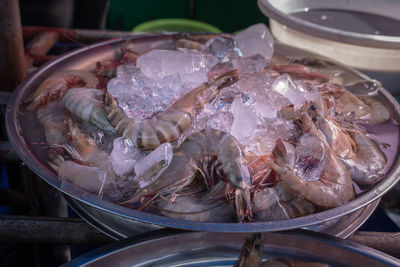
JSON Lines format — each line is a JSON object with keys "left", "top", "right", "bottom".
{"left": 63, "top": 230, "right": 400, "bottom": 267}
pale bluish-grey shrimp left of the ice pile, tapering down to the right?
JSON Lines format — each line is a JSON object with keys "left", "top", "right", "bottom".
{"left": 62, "top": 88, "right": 115, "bottom": 133}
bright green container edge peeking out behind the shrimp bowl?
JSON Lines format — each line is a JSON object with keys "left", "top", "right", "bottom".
{"left": 132, "top": 19, "right": 222, "bottom": 33}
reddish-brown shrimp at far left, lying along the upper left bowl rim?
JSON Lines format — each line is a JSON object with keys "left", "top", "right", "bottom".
{"left": 25, "top": 70, "right": 99, "bottom": 111}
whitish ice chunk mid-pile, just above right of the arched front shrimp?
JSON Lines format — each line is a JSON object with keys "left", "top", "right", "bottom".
{"left": 231, "top": 98, "right": 257, "bottom": 142}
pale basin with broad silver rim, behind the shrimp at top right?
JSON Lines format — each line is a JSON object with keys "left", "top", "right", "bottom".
{"left": 258, "top": 0, "right": 400, "bottom": 95}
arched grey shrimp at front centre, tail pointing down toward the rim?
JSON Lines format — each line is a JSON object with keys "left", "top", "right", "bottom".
{"left": 123, "top": 128, "right": 251, "bottom": 221}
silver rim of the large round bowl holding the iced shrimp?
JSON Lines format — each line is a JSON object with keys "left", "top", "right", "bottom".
{"left": 6, "top": 33, "right": 400, "bottom": 233}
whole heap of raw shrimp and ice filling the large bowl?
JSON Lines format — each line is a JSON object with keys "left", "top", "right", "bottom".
{"left": 25, "top": 24, "right": 391, "bottom": 222}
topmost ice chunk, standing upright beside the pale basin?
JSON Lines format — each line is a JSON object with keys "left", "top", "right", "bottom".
{"left": 234, "top": 23, "right": 274, "bottom": 62}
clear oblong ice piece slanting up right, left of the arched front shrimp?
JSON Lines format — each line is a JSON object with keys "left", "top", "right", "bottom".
{"left": 134, "top": 143, "right": 173, "bottom": 188}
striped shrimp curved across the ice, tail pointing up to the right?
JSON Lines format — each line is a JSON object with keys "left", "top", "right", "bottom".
{"left": 106, "top": 70, "right": 239, "bottom": 150}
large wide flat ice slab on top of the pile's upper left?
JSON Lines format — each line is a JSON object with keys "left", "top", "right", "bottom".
{"left": 137, "top": 50, "right": 218, "bottom": 80}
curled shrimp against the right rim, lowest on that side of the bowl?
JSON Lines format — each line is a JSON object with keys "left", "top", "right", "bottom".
{"left": 341, "top": 133, "right": 386, "bottom": 184}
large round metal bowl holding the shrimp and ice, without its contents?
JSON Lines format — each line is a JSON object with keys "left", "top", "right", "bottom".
{"left": 6, "top": 34, "right": 400, "bottom": 238}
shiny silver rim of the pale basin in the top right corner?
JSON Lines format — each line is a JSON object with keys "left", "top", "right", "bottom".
{"left": 258, "top": 0, "right": 400, "bottom": 49}
